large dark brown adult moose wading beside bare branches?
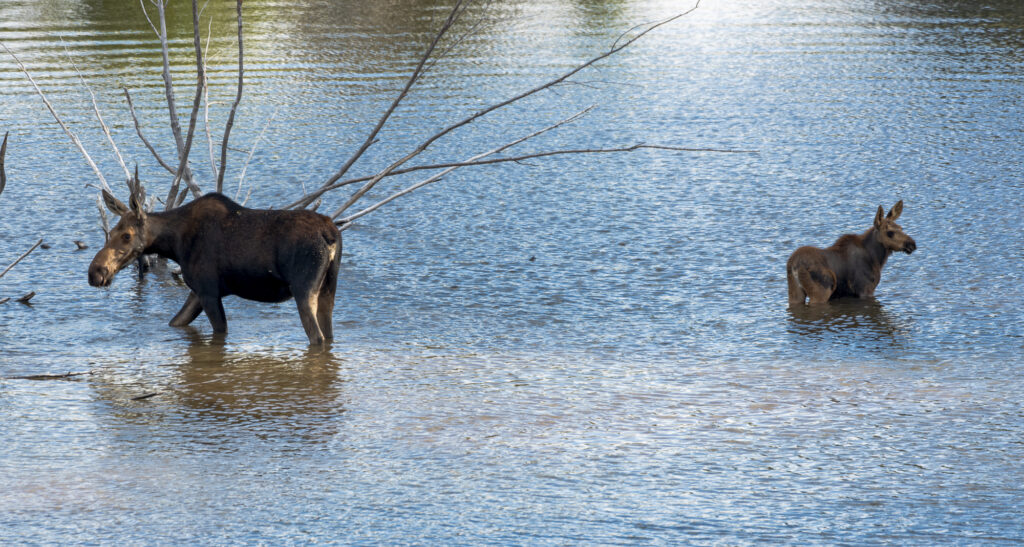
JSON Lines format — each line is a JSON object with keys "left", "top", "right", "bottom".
{"left": 89, "top": 182, "right": 341, "bottom": 345}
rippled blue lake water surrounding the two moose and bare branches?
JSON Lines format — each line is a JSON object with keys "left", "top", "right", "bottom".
{"left": 0, "top": 0, "right": 1024, "bottom": 545}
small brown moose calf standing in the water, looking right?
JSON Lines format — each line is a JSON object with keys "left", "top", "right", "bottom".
{"left": 785, "top": 200, "right": 918, "bottom": 305}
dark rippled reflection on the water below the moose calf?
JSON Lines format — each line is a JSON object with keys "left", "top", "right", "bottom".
{"left": 786, "top": 298, "right": 911, "bottom": 347}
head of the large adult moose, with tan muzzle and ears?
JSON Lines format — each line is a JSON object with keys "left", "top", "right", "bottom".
{"left": 89, "top": 181, "right": 150, "bottom": 287}
